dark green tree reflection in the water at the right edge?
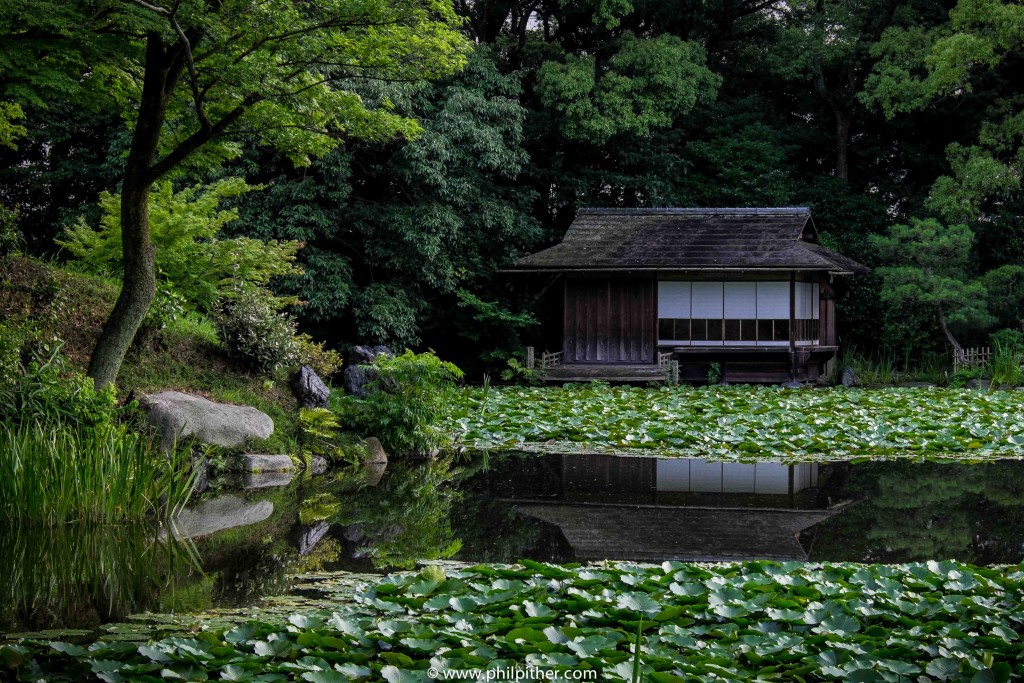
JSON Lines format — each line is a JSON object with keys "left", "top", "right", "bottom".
{"left": 812, "top": 461, "right": 1024, "bottom": 563}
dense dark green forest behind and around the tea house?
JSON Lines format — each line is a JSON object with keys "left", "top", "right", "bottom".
{"left": 0, "top": 0, "right": 1024, "bottom": 376}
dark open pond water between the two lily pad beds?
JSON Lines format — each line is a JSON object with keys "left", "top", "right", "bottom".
{"left": 0, "top": 454, "right": 1024, "bottom": 636}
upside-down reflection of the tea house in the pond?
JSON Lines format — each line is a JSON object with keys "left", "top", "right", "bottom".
{"left": 505, "top": 455, "right": 844, "bottom": 562}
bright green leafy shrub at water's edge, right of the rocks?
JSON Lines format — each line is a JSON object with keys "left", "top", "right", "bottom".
{"left": 332, "top": 351, "right": 462, "bottom": 455}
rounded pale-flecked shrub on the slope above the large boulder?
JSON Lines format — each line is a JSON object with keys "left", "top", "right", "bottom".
{"left": 213, "top": 287, "right": 299, "bottom": 373}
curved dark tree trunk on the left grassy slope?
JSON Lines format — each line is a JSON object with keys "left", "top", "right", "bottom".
{"left": 89, "top": 33, "right": 180, "bottom": 389}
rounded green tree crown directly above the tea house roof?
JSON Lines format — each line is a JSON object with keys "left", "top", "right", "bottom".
{"left": 537, "top": 31, "right": 721, "bottom": 144}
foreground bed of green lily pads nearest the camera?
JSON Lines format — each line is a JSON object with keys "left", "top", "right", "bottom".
{"left": 9, "top": 562, "right": 1024, "bottom": 683}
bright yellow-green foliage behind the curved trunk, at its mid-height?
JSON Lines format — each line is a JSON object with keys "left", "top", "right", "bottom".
{"left": 57, "top": 178, "right": 302, "bottom": 315}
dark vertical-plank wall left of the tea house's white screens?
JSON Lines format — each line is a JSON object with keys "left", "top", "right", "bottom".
{"left": 562, "top": 278, "right": 657, "bottom": 364}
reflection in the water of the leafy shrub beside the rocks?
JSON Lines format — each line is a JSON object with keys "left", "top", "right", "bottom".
{"left": 332, "top": 459, "right": 462, "bottom": 568}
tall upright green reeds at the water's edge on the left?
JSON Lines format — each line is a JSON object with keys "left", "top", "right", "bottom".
{"left": 0, "top": 422, "right": 191, "bottom": 524}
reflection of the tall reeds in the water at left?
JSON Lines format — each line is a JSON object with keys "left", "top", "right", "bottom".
{"left": 0, "top": 525, "right": 202, "bottom": 631}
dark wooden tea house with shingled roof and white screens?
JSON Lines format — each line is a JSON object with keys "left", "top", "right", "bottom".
{"left": 514, "top": 207, "right": 867, "bottom": 382}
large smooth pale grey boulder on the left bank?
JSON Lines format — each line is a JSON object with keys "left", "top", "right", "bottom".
{"left": 139, "top": 391, "right": 273, "bottom": 452}
